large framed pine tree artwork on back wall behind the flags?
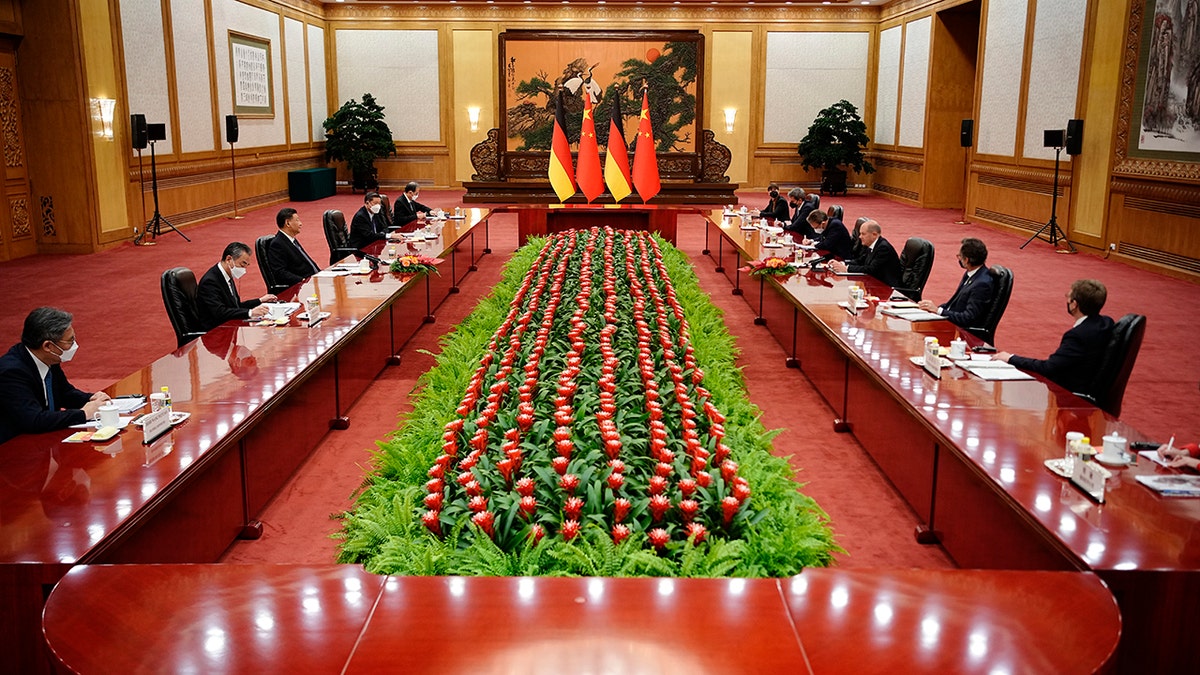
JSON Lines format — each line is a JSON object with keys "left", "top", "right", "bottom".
{"left": 499, "top": 30, "right": 704, "bottom": 157}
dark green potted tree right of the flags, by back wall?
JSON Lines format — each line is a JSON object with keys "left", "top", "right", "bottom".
{"left": 796, "top": 100, "right": 875, "bottom": 195}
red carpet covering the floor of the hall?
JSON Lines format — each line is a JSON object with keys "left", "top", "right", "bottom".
{"left": 0, "top": 190, "right": 1200, "bottom": 567}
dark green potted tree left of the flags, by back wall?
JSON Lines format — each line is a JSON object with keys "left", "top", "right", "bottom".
{"left": 322, "top": 94, "right": 396, "bottom": 190}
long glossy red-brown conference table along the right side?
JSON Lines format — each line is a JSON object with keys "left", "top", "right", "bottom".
{"left": 704, "top": 211, "right": 1200, "bottom": 673}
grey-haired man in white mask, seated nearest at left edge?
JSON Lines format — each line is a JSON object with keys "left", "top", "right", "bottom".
{"left": 0, "top": 307, "right": 108, "bottom": 443}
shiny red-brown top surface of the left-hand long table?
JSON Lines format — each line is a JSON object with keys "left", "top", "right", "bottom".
{"left": 0, "top": 209, "right": 490, "bottom": 565}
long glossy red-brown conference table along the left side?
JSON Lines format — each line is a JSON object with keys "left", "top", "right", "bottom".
{"left": 0, "top": 209, "right": 491, "bottom": 673}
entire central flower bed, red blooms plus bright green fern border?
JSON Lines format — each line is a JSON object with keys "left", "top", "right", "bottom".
{"left": 338, "top": 228, "right": 838, "bottom": 577}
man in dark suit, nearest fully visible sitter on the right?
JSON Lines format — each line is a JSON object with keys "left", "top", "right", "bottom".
{"left": 992, "top": 279, "right": 1112, "bottom": 394}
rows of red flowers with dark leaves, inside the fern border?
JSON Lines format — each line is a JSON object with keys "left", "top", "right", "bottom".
{"left": 421, "top": 228, "right": 754, "bottom": 552}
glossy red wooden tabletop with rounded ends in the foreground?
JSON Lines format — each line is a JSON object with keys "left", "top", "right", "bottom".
{"left": 44, "top": 566, "right": 1121, "bottom": 675}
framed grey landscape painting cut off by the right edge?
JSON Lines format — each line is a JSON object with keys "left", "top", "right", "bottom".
{"left": 1128, "top": 0, "right": 1200, "bottom": 162}
